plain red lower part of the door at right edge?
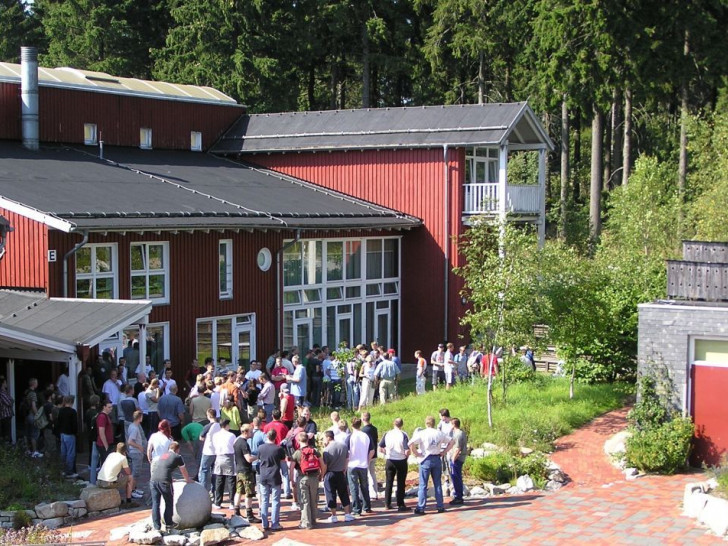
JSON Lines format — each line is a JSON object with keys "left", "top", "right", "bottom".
{"left": 690, "top": 363, "right": 728, "bottom": 466}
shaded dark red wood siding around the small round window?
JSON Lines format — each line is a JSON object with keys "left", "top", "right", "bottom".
{"left": 49, "top": 231, "right": 282, "bottom": 379}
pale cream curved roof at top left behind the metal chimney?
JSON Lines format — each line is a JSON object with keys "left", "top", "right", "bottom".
{"left": 0, "top": 63, "right": 237, "bottom": 106}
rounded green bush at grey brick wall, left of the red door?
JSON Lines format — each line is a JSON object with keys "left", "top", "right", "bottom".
{"left": 626, "top": 417, "right": 694, "bottom": 474}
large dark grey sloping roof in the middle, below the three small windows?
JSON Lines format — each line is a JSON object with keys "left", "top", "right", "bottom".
{"left": 0, "top": 143, "right": 421, "bottom": 231}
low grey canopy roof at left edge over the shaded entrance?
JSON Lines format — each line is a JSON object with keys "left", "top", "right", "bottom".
{"left": 0, "top": 290, "right": 152, "bottom": 353}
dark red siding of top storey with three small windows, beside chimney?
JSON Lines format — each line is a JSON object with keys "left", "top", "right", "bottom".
{"left": 0, "top": 83, "right": 244, "bottom": 150}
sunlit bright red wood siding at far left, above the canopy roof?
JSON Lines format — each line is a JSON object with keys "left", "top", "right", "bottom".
{"left": 0, "top": 209, "right": 48, "bottom": 291}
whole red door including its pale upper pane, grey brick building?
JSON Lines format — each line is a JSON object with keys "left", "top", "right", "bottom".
{"left": 690, "top": 339, "right": 728, "bottom": 466}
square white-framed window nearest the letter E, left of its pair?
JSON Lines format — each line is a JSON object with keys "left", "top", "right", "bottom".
{"left": 76, "top": 243, "right": 119, "bottom": 299}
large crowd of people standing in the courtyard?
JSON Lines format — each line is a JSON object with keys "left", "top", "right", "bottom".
{"left": 8, "top": 342, "right": 484, "bottom": 530}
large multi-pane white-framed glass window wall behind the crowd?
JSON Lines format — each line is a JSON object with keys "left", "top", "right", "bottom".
{"left": 283, "top": 237, "right": 401, "bottom": 349}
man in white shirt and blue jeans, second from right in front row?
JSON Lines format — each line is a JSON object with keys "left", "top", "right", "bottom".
{"left": 409, "top": 415, "right": 452, "bottom": 515}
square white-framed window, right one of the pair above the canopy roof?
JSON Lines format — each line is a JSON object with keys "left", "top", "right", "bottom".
{"left": 130, "top": 241, "right": 169, "bottom": 303}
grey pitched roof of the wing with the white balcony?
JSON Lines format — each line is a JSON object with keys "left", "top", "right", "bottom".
{"left": 212, "top": 102, "right": 553, "bottom": 153}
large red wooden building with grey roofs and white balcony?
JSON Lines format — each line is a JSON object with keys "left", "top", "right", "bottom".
{"left": 0, "top": 47, "right": 551, "bottom": 386}
